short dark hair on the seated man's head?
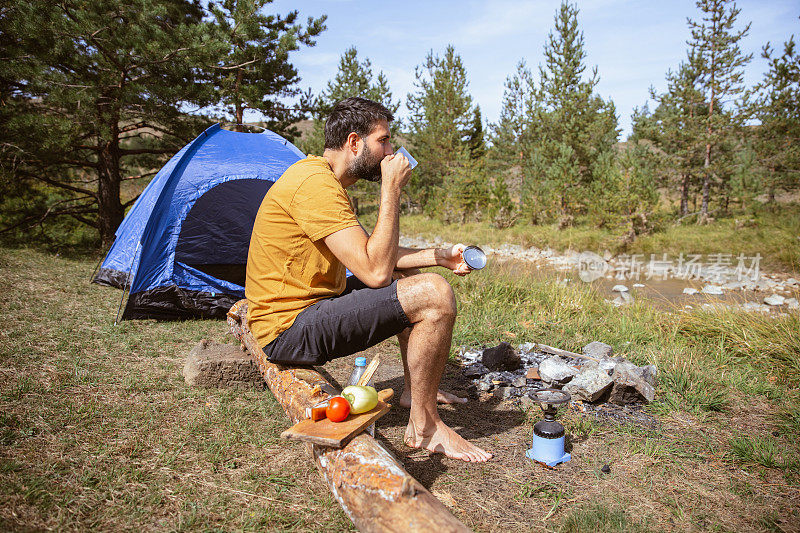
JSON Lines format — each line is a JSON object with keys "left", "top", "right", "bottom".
{"left": 325, "top": 96, "right": 394, "bottom": 150}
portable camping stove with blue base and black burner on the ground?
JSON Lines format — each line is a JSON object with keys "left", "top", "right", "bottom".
{"left": 525, "top": 389, "right": 572, "bottom": 466}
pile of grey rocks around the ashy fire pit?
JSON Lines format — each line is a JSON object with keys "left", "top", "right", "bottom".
{"left": 459, "top": 341, "right": 658, "bottom": 405}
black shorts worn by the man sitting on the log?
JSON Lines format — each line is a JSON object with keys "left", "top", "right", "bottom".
{"left": 264, "top": 276, "right": 411, "bottom": 365}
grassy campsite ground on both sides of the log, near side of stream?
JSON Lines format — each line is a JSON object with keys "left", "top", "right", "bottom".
{"left": 0, "top": 248, "right": 800, "bottom": 532}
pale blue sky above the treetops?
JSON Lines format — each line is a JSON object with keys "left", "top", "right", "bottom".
{"left": 267, "top": 0, "right": 800, "bottom": 139}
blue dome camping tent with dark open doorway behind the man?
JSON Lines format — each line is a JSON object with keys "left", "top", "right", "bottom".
{"left": 93, "top": 124, "right": 305, "bottom": 320}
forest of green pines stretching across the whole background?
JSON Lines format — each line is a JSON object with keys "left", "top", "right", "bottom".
{"left": 0, "top": 0, "right": 800, "bottom": 254}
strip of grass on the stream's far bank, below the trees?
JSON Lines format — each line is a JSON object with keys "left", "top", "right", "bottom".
{"left": 372, "top": 203, "right": 800, "bottom": 272}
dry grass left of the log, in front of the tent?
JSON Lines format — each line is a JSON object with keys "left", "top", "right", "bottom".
{"left": 0, "top": 250, "right": 351, "bottom": 531}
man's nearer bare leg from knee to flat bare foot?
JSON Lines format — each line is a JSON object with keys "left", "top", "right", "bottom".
{"left": 397, "top": 274, "right": 492, "bottom": 462}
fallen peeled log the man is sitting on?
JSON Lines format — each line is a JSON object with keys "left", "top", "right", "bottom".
{"left": 228, "top": 300, "right": 470, "bottom": 532}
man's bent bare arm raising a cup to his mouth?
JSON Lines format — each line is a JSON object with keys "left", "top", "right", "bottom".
{"left": 323, "top": 155, "right": 411, "bottom": 288}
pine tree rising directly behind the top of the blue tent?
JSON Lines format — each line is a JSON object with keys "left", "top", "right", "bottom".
{"left": 209, "top": 0, "right": 326, "bottom": 139}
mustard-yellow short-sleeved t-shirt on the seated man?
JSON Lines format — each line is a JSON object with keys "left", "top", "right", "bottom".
{"left": 245, "top": 155, "right": 358, "bottom": 347}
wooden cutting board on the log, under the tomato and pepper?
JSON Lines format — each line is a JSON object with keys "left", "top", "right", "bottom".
{"left": 281, "top": 389, "right": 394, "bottom": 448}
